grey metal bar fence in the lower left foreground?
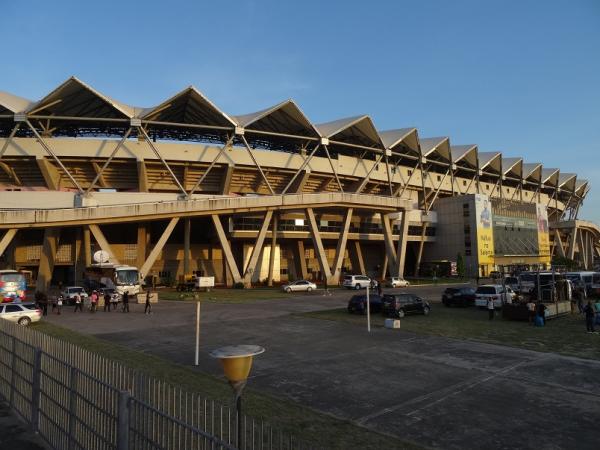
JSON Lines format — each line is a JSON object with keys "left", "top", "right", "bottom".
{"left": 0, "top": 320, "right": 312, "bottom": 450}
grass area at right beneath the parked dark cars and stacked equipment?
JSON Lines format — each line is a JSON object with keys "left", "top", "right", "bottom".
{"left": 301, "top": 305, "right": 600, "bottom": 359}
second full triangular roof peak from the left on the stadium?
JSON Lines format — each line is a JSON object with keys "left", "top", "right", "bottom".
{"left": 139, "top": 86, "right": 236, "bottom": 128}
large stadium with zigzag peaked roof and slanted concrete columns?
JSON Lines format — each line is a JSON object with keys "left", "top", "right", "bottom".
{"left": 0, "top": 77, "right": 600, "bottom": 290}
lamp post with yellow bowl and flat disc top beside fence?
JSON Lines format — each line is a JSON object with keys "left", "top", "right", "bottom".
{"left": 210, "top": 345, "right": 265, "bottom": 448}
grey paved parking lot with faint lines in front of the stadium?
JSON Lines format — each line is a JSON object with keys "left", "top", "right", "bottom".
{"left": 42, "top": 286, "right": 600, "bottom": 449}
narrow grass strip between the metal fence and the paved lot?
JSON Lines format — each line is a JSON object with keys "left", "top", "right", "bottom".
{"left": 31, "top": 321, "right": 421, "bottom": 450}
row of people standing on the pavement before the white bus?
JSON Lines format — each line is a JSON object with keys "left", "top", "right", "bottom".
{"left": 35, "top": 289, "right": 152, "bottom": 316}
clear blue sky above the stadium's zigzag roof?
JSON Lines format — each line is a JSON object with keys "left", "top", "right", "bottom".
{"left": 0, "top": 0, "right": 600, "bottom": 222}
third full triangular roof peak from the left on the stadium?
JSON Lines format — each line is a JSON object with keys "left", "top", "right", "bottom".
{"left": 233, "top": 100, "right": 320, "bottom": 138}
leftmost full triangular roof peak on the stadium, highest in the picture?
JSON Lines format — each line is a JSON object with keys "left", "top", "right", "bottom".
{"left": 25, "top": 77, "right": 136, "bottom": 119}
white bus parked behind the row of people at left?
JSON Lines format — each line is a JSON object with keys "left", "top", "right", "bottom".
{"left": 84, "top": 263, "right": 141, "bottom": 295}
